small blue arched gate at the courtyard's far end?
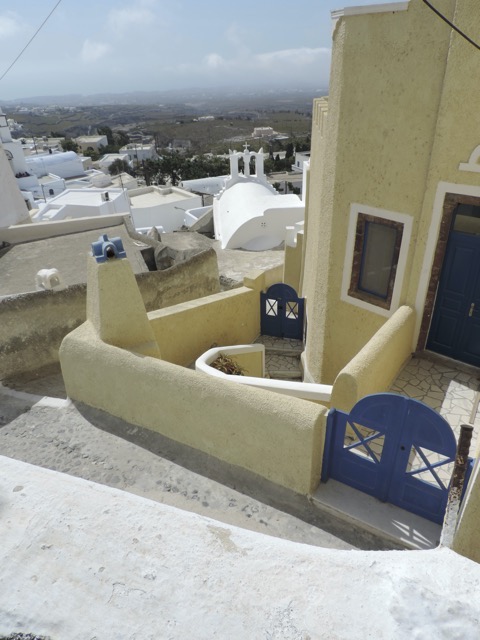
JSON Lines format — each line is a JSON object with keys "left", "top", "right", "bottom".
{"left": 260, "top": 283, "right": 304, "bottom": 340}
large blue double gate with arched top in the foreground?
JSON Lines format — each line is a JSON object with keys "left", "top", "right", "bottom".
{"left": 322, "top": 393, "right": 456, "bottom": 524}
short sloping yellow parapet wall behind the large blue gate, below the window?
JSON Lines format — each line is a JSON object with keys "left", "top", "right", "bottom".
{"left": 331, "top": 306, "right": 415, "bottom": 411}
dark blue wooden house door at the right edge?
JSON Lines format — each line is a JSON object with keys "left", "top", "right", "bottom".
{"left": 427, "top": 231, "right": 480, "bottom": 367}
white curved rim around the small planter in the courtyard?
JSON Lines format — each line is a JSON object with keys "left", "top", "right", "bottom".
{"left": 195, "top": 344, "right": 333, "bottom": 402}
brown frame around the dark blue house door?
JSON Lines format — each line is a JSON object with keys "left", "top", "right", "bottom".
{"left": 416, "top": 192, "right": 480, "bottom": 351}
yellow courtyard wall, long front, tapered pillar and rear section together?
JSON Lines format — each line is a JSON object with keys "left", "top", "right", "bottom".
{"left": 59, "top": 258, "right": 327, "bottom": 494}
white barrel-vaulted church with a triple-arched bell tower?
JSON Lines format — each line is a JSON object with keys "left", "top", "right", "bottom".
{"left": 213, "top": 148, "right": 305, "bottom": 251}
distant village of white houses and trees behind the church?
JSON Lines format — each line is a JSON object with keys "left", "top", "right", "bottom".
{"left": 0, "top": 106, "right": 309, "bottom": 249}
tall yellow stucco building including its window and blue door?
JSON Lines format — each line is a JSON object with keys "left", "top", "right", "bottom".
{"left": 301, "top": 0, "right": 480, "bottom": 383}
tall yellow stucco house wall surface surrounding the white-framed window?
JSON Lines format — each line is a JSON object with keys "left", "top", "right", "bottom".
{"left": 303, "top": 0, "right": 480, "bottom": 384}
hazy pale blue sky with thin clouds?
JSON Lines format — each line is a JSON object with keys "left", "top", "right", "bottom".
{"left": 0, "top": 0, "right": 398, "bottom": 104}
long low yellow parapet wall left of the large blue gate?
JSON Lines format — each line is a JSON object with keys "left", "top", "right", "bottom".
{"left": 60, "top": 323, "right": 327, "bottom": 494}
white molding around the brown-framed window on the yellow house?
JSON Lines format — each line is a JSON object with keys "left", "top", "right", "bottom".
{"left": 340, "top": 202, "right": 413, "bottom": 318}
